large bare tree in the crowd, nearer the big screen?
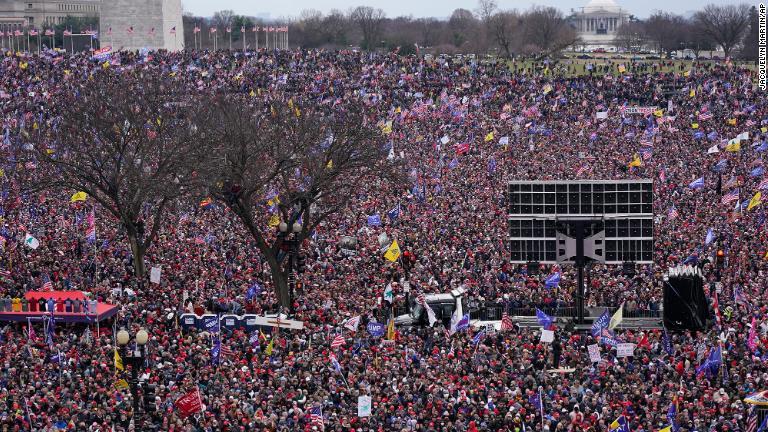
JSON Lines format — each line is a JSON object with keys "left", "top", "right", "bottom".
{"left": 198, "top": 96, "right": 399, "bottom": 308}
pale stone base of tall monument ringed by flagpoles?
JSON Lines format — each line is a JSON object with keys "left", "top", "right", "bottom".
{"left": 100, "top": 0, "right": 184, "bottom": 51}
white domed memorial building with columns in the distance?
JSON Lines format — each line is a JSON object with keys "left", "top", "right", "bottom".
{"left": 569, "top": 0, "right": 629, "bottom": 49}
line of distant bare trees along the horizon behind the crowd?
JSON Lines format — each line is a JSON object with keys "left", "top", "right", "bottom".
{"left": 185, "top": 0, "right": 758, "bottom": 59}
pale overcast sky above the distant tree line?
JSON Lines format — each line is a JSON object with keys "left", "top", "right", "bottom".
{"left": 182, "top": 0, "right": 738, "bottom": 19}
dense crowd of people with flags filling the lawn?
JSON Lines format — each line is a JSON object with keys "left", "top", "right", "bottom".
{"left": 0, "top": 45, "right": 768, "bottom": 431}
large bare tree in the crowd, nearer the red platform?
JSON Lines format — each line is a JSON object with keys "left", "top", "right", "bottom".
{"left": 34, "top": 71, "right": 197, "bottom": 283}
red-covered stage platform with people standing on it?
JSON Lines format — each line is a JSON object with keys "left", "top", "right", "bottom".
{"left": 0, "top": 291, "right": 117, "bottom": 323}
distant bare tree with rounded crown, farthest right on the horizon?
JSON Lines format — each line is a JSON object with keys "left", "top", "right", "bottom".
{"left": 694, "top": 3, "right": 749, "bottom": 57}
